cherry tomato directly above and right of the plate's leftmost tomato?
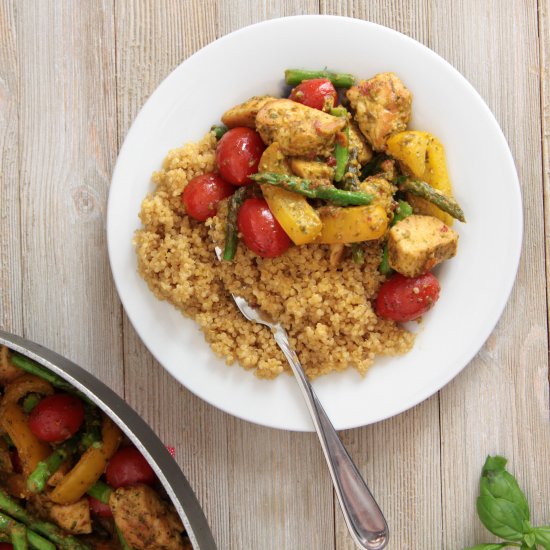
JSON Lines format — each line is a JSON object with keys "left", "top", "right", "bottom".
{"left": 216, "top": 127, "right": 265, "bottom": 185}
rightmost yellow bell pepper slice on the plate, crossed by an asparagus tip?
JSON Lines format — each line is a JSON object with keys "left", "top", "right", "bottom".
{"left": 387, "top": 130, "right": 454, "bottom": 225}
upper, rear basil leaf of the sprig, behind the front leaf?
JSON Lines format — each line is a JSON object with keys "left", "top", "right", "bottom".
{"left": 479, "top": 455, "right": 530, "bottom": 520}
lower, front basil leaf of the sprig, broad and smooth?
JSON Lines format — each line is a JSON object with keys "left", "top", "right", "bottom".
{"left": 477, "top": 496, "right": 524, "bottom": 541}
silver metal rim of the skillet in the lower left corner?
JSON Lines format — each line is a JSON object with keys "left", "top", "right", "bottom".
{"left": 0, "top": 330, "right": 216, "bottom": 550}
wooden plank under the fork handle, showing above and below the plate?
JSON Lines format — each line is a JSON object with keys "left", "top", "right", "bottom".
{"left": 321, "top": 0, "right": 442, "bottom": 550}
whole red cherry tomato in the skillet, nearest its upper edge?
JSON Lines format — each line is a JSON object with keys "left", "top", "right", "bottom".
{"left": 29, "top": 393, "right": 84, "bottom": 443}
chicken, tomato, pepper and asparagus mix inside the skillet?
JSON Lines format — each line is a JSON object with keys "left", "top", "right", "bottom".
{"left": 0, "top": 346, "right": 191, "bottom": 550}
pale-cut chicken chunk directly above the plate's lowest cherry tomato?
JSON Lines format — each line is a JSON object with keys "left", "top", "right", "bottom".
{"left": 388, "top": 215, "right": 458, "bottom": 277}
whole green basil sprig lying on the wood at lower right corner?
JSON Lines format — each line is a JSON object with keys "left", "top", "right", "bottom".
{"left": 465, "top": 456, "right": 550, "bottom": 550}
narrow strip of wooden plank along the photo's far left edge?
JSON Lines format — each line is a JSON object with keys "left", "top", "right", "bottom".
{"left": 0, "top": 0, "right": 23, "bottom": 334}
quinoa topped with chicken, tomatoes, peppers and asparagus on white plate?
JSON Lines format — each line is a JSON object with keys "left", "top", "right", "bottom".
{"left": 135, "top": 70, "right": 465, "bottom": 378}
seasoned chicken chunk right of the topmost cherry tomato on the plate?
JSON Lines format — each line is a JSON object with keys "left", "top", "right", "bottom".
{"left": 346, "top": 73, "right": 412, "bottom": 151}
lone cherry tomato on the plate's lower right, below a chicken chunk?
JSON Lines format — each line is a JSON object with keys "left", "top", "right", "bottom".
{"left": 376, "top": 273, "right": 440, "bottom": 322}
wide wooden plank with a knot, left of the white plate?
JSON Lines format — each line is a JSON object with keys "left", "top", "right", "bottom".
{"left": 17, "top": 0, "right": 122, "bottom": 393}
